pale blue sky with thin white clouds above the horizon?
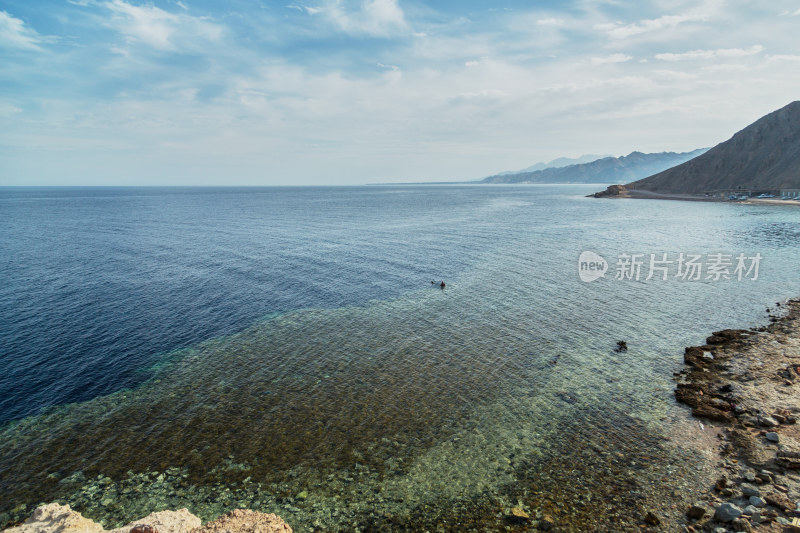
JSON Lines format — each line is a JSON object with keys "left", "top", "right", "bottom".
{"left": 0, "top": 0, "right": 800, "bottom": 186}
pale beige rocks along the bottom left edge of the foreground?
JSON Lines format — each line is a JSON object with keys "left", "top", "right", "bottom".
{"left": 3, "top": 503, "right": 292, "bottom": 533}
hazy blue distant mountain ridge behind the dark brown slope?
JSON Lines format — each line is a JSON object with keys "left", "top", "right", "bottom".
{"left": 481, "top": 148, "right": 707, "bottom": 183}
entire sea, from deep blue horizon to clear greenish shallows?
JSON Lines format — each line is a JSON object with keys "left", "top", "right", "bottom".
{"left": 0, "top": 184, "right": 800, "bottom": 531}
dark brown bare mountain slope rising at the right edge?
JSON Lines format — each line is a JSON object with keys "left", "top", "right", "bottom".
{"left": 617, "top": 101, "right": 800, "bottom": 194}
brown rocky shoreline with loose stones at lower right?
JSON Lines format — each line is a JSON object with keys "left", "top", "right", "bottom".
{"left": 675, "top": 300, "right": 800, "bottom": 533}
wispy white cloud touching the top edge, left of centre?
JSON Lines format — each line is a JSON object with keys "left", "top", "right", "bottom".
{"left": 103, "top": 0, "right": 222, "bottom": 51}
